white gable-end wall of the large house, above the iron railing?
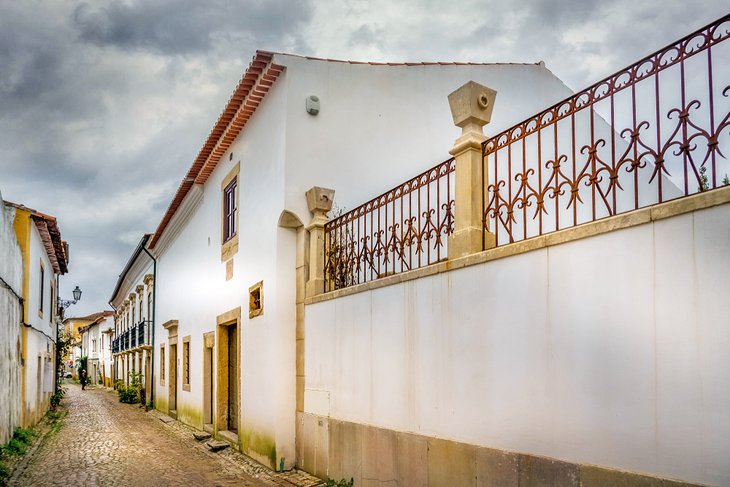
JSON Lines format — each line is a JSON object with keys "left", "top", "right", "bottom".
{"left": 274, "top": 55, "right": 572, "bottom": 223}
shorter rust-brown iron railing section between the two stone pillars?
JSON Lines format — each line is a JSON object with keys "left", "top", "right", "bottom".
{"left": 324, "top": 158, "right": 455, "bottom": 291}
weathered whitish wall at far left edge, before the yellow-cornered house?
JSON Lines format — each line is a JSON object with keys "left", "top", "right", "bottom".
{"left": 0, "top": 194, "right": 23, "bottom": 444}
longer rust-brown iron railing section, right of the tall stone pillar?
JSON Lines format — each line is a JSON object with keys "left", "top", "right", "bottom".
{"left": 483, "top": 15, "right": 730, "bottom": 245}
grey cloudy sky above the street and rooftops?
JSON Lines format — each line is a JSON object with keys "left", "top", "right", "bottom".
{"left": 0, "top": 0, "right": 728, "bottom": 315}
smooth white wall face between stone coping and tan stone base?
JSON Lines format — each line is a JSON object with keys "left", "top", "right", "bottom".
{"left": 305, "top": 201, "right": 730, "bottom": 485}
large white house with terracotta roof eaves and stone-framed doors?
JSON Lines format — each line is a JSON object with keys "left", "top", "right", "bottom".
{"left": 142, "top": 52, "right": 570, "bottom": 468}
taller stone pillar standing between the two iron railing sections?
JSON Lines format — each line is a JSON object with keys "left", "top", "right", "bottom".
{"left": 448, "top": 81, "right": 497, "bottom": 259}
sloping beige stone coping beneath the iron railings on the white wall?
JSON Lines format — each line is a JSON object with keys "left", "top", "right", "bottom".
{"left": 304, "top": 186, "right": 730, "bottom": 304}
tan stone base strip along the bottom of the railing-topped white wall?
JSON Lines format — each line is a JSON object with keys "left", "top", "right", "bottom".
{"left": 296, "top": 413, "right": 699, "bottom": 487}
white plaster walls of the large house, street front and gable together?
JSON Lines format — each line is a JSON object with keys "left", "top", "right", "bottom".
{"left": 149, "top": 55, "right": 604, "bottom": 467}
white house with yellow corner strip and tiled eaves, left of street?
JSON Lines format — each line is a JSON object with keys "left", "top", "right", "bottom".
{"left": 5, "top": 201, "right": 68, "bottom": 427}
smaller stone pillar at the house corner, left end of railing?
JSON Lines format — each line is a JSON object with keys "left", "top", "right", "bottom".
{"left": 306, "top": 186, "right": 335, "bottom": 297}
